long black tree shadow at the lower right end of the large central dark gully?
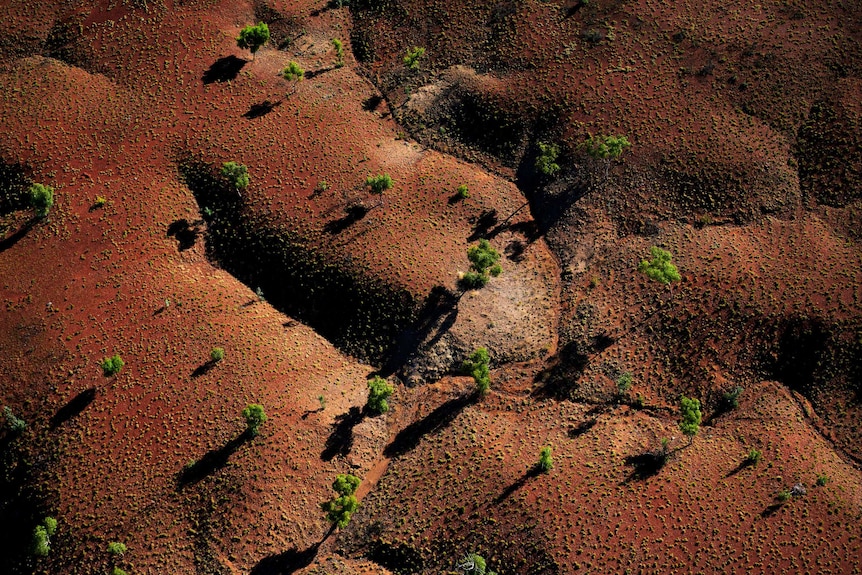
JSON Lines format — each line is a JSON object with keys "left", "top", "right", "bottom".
{"left": 380, "top": 285, "right": 462, "bottom": 378}
